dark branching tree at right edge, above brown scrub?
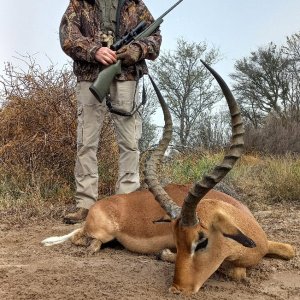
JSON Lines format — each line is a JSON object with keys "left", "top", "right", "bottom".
{"left": 231, "top": 39, "right": 299, "bottom": 128}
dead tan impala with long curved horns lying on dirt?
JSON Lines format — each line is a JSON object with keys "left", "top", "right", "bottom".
{"left": 42, "top": 63, "right": 295, "bottom": 294}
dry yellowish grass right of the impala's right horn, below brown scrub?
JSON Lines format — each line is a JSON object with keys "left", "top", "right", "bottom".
{"left": 232, "top": 155, "right": 300, "bottom": 204}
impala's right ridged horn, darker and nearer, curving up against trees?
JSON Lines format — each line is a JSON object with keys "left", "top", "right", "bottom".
{"left": 181, "top": 60, "right": 244, "bottom": 226}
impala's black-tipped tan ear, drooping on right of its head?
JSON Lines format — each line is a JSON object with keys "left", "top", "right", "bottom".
{"left": 212, "top": 211, "right": 256, "bottom": 248}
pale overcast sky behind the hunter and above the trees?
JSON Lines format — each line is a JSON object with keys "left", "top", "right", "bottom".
{"left": 0, "top": 0, "right": 300, "bottom": 122}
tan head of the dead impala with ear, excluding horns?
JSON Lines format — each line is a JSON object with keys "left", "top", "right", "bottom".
{"left": 170, "top": 209, "right": 256, "bottom": 294}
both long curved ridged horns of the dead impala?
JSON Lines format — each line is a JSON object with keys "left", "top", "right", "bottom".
{"left": 144, "top": 60, "right": 244, "bottom": 226}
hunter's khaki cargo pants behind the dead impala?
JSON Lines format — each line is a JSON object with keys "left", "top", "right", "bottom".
{"left": 75, "top": 81, "right": 142, "bottom": 208}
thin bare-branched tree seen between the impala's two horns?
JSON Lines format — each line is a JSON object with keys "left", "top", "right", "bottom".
{"left": 151, "top": 39, "right": 221, "bottom": 146}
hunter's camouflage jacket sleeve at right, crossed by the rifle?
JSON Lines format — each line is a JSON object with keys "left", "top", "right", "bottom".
{"left": 136, "top": 1, "right": 162, "bottom": 60}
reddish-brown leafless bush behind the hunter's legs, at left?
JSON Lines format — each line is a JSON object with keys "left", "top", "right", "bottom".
{"left": 0, "top": 58, "right": 118, "bottom": 206}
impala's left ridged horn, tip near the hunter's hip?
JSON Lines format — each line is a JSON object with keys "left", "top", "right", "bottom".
{"left": 144, "top": 76, "right": 181, "bottom": 219}
